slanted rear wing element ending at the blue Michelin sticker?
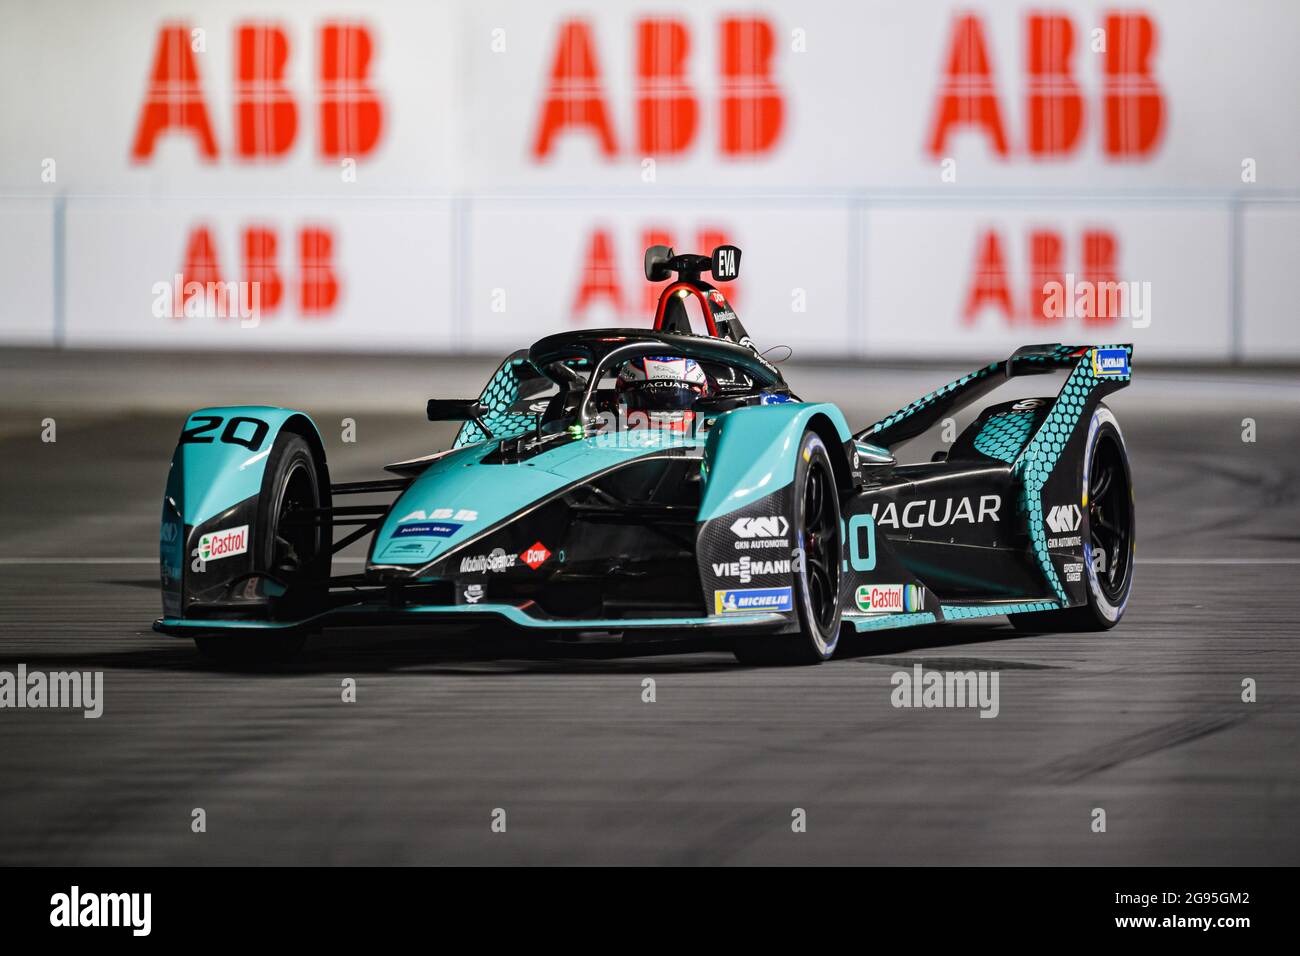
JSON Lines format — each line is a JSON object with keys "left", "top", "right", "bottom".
{"left": 854, "top": 345, "right": 1134, "bottom": 449}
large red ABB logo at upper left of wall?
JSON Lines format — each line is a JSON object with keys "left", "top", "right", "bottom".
{"left": 131, "top": 21, "right": 384, "bottom": 163}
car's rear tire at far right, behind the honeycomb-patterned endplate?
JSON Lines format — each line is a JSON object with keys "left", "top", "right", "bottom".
{"left": 1010, "top": 405, "right": 1136, "bottom": 632}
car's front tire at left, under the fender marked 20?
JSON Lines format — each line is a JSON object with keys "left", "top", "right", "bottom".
{"left": 195, "top": 432, "right": 333, "bottom": 666}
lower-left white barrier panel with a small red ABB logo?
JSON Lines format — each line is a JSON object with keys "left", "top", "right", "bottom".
{"left": 65, "top": 199, "right": 454, "bottom": 351}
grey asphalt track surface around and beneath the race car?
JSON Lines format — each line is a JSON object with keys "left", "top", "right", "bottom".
{"left": 0, "top": 350, "right": 1300, "bottom": 865}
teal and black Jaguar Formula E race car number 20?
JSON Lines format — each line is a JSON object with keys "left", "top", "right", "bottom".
{"left": 155, "top": 246, "right": 1134, "bottom": 663}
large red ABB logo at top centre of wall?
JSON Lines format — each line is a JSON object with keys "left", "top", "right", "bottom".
{"left": 530, "top": 17, "right": 787, "bottom": 163}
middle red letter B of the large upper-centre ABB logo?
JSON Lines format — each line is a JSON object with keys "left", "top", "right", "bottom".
{"left": 637, "top": 20, "right": 699, "bottom": 156}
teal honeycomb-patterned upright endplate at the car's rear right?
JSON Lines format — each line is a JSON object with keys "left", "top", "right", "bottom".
{"left": 1013, "top": 346, "right": 1132, "bottom": 605}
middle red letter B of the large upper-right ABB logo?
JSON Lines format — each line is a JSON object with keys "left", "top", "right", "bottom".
{"left": 1026, "top": 16, "right": 1083, "bottom": 156}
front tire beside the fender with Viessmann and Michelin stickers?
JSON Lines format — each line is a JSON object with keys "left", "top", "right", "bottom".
{"left": 733, "top": 431, "right": 844, "bottom": 665}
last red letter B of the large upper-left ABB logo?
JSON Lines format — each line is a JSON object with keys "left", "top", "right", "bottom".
{"left": 320, "top": 23, "right": 384, "bottom": 159}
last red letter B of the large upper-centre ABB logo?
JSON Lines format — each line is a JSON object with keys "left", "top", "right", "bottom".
{"left": 722, "top": 17, "right": 785, "bottom": 156}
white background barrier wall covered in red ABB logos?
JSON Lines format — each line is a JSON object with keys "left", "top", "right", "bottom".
{"left": 0, "top": 0, "right": 1300, "bottom": 360}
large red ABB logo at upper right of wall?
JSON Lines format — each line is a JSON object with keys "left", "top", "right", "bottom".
{"left": 927, "top": 13, "right": 1166, "bottom": 160}
